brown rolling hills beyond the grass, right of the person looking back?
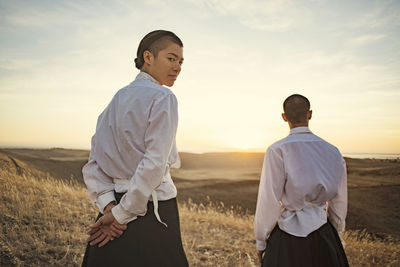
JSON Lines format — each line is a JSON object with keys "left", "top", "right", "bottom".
{"left": 176, "top": 153, "right": 400, "bottom": 239}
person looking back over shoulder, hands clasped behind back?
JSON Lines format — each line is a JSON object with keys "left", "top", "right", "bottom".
{"left": 82, "top": 30, "right": 188, "bottom": 267}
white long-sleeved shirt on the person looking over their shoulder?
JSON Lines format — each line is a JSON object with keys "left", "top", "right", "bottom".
{"left": 82, "top": 72, "right": 179, "bottom": 224}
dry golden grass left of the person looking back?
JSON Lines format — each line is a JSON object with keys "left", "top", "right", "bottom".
{"left": 0, "top": 169, "right": 96, "bottom": 266}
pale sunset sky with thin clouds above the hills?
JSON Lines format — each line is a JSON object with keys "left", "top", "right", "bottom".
{"left": 0, "top": 0, "right": 400, "bottom": 153}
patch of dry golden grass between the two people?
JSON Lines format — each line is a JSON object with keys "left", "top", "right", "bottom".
{"left": 180, "top": 201, "right": 257, "bottom": 266}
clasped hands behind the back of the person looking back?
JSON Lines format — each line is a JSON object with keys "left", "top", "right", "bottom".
{"left": 87, "top": 203, "right": 127, "bottom": 247}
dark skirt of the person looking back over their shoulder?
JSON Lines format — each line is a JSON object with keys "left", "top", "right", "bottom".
{"left": 82, "top": 194, "right": 188, "bottom": 267}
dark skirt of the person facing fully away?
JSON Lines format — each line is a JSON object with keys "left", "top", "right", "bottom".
{"left": 262, "top": 221, "right": 349, "bottom": 267}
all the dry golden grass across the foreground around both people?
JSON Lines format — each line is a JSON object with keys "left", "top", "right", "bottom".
{"left": 0, "top": 168, "right": 400, "bottom": 266}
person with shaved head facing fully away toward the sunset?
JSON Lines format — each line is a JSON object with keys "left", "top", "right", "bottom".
{"left": 254, "top": 94, "right": 349, "bottom": 267}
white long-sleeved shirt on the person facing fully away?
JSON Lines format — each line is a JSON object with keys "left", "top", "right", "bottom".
{"left": 254, "top": 127, "right": 347, "bottom": 250}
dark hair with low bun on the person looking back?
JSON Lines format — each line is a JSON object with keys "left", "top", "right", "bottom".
{"left": 135, "top": 30, "right": 183, "bottom": 70}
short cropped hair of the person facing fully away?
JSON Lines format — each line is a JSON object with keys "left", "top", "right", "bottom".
{"left": 283, "top": 94, "right": 310, "bottom": 123}
